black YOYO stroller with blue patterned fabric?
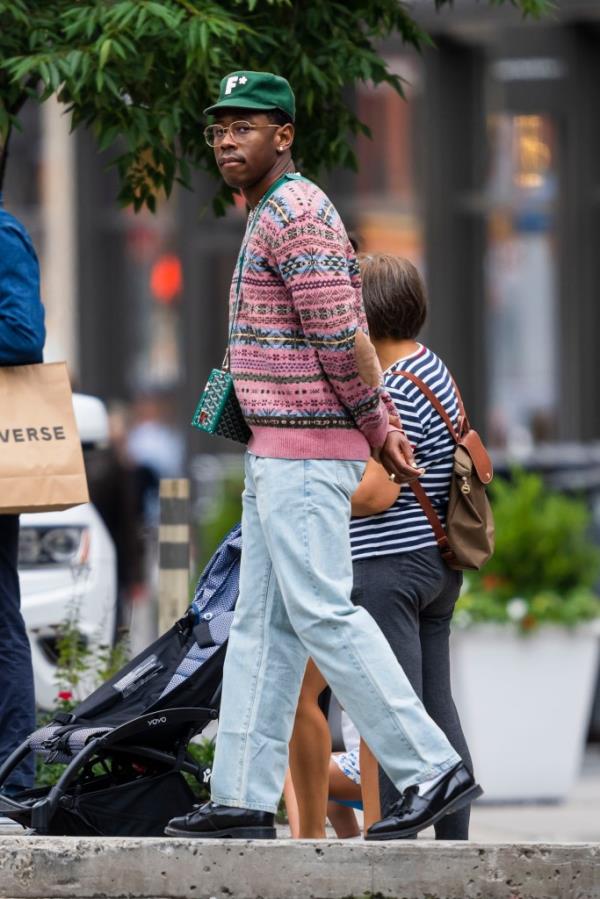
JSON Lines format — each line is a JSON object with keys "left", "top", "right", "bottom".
{"left": 0, "top": 525, "right": 241, "bottom": 836}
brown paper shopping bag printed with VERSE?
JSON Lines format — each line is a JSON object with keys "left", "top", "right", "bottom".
{"left": 0, "top": 362, "right": 89, "bottom": 514}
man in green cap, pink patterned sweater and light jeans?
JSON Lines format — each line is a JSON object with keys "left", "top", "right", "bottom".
{"left": 166, "top": 72, "right": 481, "bottom": 838}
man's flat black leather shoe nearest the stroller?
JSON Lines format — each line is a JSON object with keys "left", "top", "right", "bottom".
{"left": 165, "top": 802, "right": 277, "bottom": 840}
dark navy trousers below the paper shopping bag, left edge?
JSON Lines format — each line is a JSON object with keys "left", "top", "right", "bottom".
{"left": 0, "top": 515, "right": 35, "bottom": 792}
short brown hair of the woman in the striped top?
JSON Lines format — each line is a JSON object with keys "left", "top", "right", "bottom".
{"left": 359, "top": 253, "right": 427, "bottom": 340}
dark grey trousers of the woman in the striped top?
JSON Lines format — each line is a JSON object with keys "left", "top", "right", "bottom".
{"left": 352, "top": 547, "right": 471, "bottom": 840}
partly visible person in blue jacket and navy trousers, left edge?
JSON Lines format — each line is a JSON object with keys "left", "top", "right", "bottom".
{"left": 0, "top": 194, "right": 46, "bottom": 795}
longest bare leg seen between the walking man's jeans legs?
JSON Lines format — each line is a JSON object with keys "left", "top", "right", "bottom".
{"left": 290, "top": 659, "right": 331, "bottom": 839}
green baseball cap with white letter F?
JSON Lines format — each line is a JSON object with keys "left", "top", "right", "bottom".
{"left": 204, "top": 72, "right": 296, "bottom": 121}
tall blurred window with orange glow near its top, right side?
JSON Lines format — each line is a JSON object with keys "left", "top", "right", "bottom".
{"left": 485, "top": 113, "right": 558, "bottom": 453}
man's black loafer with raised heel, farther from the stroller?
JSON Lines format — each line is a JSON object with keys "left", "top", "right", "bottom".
{"left": 365, "top": 762, "right": 483, "bottom": 840}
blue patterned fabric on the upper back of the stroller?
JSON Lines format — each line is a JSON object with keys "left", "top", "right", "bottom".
{"left": 161, "top": 524, "right": 242, "bottom": 699}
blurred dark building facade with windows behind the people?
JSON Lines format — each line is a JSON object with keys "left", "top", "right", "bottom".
{"left": 5, "top": 0, "right": 600, "bottom": 735}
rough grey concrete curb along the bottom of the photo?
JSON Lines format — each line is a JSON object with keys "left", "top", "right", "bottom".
{"left": 0, "top": 836, "right": 600, "bottom": 899}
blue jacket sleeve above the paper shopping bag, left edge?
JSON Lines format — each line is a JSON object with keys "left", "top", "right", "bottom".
{"left": 0, "top": 213, "right": 46, "bottom": 365}
